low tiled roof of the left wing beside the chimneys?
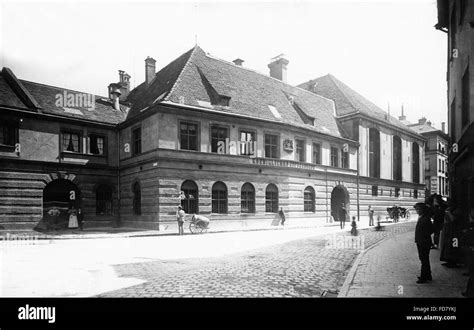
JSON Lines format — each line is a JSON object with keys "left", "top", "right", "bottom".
{"left": 0, "top": 68, "right": 126, "bottom": 124}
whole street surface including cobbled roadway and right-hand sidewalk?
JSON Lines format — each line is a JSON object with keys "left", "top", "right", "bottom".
{"left": 0, "top": 221, "right": 467, "bottom": 297}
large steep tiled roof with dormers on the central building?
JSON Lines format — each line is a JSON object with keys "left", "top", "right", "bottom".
{"left": 127, "top": 46, "right": 342, "bottom": 137}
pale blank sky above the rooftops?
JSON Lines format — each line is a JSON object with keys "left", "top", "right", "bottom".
{"left": 0, "top": 0, "right": 447, "bottom": 128}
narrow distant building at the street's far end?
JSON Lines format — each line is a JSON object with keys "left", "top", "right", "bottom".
{"left": 406, "top": 115, "right": 450, "bottom": 199}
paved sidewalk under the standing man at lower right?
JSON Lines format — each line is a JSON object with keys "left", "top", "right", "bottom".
{"left": 338, "top": 231, "right": 468, "bottom": 298}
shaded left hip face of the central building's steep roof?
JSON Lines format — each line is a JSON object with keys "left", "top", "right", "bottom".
{"left": 127, "top": 46, "right": 197, "bottom": 118}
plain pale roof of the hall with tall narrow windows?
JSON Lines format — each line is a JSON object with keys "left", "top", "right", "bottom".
{"left": 298, "top": 74, "right": 420, "bottom": 133}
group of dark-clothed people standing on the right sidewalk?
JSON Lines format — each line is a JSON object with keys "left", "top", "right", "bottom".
{"left": 414, "top": 194, "right": 474, "bottom": 297}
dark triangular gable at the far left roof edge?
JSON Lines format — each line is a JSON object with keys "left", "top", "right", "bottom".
{"left": 0, "top": 67, "right": 41, "bottom": 111}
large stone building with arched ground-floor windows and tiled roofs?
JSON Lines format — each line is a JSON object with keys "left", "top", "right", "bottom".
{"left": 0, "top": 46, "right": 425, "bottom": 230}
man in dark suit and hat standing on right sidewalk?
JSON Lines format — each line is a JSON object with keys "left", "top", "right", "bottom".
{"left": 414, "top": 203, "right": 433, "bottom": 283}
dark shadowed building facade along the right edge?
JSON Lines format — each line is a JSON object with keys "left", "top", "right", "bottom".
{"left": 436, "top": 0, "right": 474, "bottom": 213}
